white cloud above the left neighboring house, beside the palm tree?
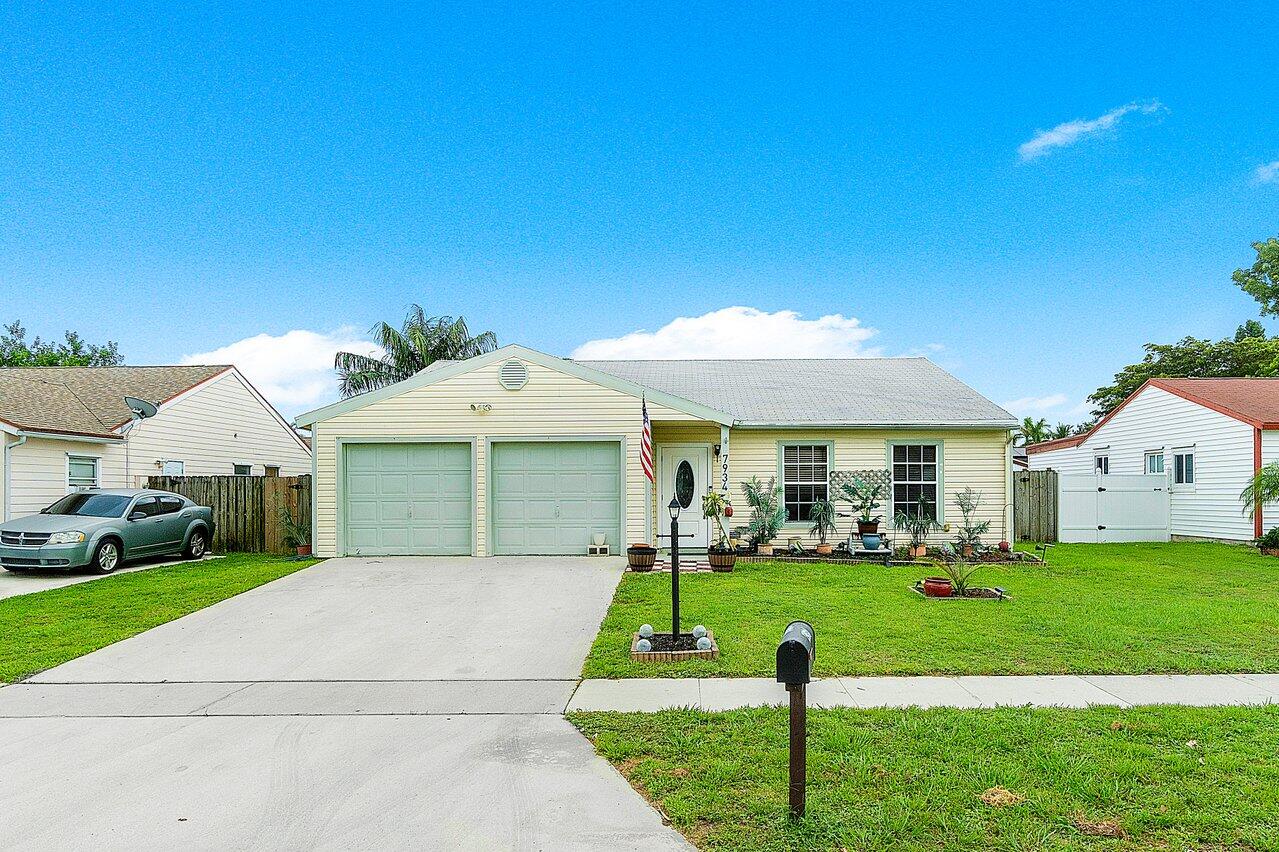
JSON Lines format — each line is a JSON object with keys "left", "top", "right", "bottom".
{"left": 182, "top": 326, "right": 381, "bottom": 418}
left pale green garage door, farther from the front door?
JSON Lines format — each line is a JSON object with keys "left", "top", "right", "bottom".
{"left": 343, "top": 444, "right": 473, "bottom": 555}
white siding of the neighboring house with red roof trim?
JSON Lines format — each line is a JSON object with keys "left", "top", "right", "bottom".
{"left": 1028, "top": 386, "right": 1258, "bottom": 541}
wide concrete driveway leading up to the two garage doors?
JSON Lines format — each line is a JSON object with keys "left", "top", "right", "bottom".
{"left": 0, "top": 558, "right": 691, "bottom": 849}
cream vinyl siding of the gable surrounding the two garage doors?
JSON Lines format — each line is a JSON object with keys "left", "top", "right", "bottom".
{"left": 313, "top": 361, "right": 694, "bottom": 556}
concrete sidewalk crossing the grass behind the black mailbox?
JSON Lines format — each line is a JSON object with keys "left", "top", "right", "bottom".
{"left": 568, "top": 674, "right": 1279, "bottom": 713}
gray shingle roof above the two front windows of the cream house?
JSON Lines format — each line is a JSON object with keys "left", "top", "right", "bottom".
{"left": 577, "top": 358, "right": 1017, "bottom": 427}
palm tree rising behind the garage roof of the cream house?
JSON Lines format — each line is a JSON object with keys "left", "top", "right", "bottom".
{"left": 334, "top": 304, "right": 498, "bottom": 397}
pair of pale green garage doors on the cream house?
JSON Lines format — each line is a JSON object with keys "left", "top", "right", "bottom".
{"left": 339, "top": 438, "right": 623, "bottom": 555}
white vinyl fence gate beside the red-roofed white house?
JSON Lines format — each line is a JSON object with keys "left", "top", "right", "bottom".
{"left": 1056, "top": 473, "right": 1172, "bottom": 544}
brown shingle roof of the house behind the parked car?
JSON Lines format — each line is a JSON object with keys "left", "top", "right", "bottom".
{"left": 0, "top": 365, "right": 230, "bottom": 438}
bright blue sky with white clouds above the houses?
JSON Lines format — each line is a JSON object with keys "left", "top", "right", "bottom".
{"left": 0, "top": 1, "right": 1279, "bottom": 420}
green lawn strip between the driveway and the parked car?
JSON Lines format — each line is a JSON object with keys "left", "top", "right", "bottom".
{"left": 0, "top": 554, "right": 317, "bottom": 683}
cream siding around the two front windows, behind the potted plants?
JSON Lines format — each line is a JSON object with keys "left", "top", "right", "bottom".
{"left": 729, "top": 429, "right": 1012, "bottom": 544}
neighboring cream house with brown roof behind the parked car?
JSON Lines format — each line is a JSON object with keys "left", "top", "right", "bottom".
{"left": 0, "top": 366, "right": 311, "bottom": 518}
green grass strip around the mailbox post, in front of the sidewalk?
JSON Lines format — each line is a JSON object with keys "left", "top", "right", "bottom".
{"left": 570, "top": 706, "right": 1279, "bottom": 852}
